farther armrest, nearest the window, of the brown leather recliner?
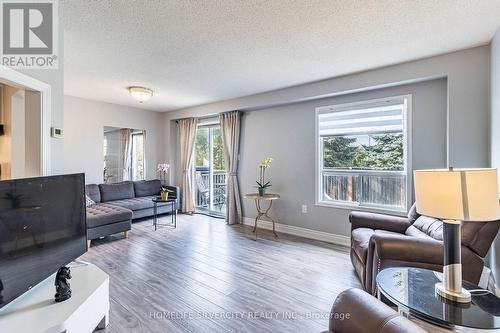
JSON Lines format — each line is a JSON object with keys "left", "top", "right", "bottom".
{"left": 349, "top": 211, "right": 411, "bottom": 234}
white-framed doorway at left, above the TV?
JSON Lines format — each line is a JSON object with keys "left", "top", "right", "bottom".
{"left": 0, "top": 67, "right": 50, "bottom": 180}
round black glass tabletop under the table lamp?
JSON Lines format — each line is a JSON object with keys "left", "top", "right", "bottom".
{"left": 377, "top": 267, "right": 500, "bottom": 330}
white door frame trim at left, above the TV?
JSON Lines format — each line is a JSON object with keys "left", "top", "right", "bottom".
{"left": 0, "top": 66, "right": 52, "bottom": 176}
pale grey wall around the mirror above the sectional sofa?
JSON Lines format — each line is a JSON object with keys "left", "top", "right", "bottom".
{"left": 64, "top": 96, "right": 165, "bottom": 183}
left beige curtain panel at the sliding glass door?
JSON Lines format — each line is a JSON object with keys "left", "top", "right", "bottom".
{"left": 177, "top": 118, "right": 198, "bottom": 214}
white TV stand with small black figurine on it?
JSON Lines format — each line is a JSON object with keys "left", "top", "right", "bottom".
{"left": 0, "top": 264, "right": 109, "bottom": 333}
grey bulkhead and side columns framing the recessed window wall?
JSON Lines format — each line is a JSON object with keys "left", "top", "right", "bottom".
{"left": 164, "top": 46, "right": 490, "bottom": 174}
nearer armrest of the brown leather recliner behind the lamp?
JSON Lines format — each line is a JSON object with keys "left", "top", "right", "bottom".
{"left": 370, "top": 234, "right": 443, "bottom": 265}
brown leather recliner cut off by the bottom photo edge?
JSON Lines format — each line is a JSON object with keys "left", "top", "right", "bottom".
{"left": 324, "top": 288, "right": 427, "bottom": 333}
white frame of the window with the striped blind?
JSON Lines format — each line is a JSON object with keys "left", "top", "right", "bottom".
{"left": 314, "top": 94, "right": 413, "bottom": 215}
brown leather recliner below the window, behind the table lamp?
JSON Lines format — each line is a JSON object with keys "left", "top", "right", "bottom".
{"left": 349, "top": 205, "right": 500, "bottom": 295}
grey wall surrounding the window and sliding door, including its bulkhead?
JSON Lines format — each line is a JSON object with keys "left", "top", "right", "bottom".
{"left": 164, "top": 46, "right": 490, "bottom": 236}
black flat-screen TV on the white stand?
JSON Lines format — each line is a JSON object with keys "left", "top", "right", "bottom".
{"left": 0, "top": 174, "right": 87, "bottom": 308}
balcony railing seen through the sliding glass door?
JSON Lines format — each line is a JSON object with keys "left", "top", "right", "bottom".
{"left": 195, "top": 168, "right": 226, "bottom": 212}
